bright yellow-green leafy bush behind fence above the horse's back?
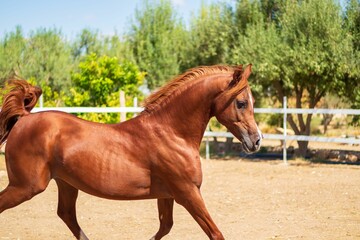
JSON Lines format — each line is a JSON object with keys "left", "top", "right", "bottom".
{"left": 65, "top": 53, "right": 144, "bottom": 123}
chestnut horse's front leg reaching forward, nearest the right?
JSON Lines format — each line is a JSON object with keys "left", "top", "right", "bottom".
{"left": 175, "top": 183, "right": 224, "bottom": 240}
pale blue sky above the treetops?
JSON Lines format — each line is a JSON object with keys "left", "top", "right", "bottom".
{"left": 0, "top": 0, "right": 234, "bottom": 39}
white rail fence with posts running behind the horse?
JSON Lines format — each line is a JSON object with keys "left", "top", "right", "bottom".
{"left": 33, "top": 98, "right": 360, "bottom": 164}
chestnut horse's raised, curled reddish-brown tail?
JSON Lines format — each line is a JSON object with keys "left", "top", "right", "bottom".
{"left": 0, "top": 79, "right": 42, "bottom": 144}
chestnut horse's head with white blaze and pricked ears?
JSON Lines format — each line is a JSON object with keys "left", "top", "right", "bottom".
{"left": 214, "top": 65, "right": 262, "bottom": 153}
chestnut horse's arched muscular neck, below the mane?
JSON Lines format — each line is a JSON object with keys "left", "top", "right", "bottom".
{"left": 143, "top": 74, "right": 226, "bottom": 144}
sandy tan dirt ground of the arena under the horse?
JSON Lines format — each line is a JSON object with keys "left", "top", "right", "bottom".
{"left": 0, "top": 159, "right": 360, "bottom": 240}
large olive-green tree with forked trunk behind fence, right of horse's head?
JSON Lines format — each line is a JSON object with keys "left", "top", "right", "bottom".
{"left": 232, "top": 0, "right": 353, "bottom": 156}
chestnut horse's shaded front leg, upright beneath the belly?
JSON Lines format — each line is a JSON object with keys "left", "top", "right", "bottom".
{"left": 150, "top": 198, "right": 174, "bottom": 240}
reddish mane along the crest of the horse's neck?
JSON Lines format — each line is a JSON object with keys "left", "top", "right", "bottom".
{"left": 143, "top": 65, "right": 234, "bottom": 113}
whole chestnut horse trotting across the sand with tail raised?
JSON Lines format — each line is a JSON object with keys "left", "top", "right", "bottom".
{"left": 0, "top": 65, "right": 262, "bottom": 239}
